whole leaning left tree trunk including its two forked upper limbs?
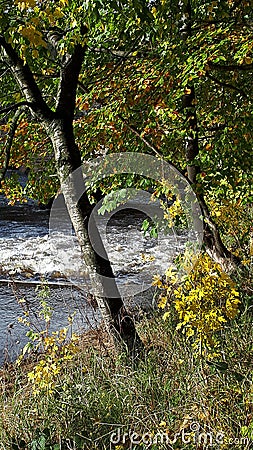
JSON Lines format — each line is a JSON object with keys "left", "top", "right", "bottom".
{"left": 0, "top": 33, "right": 143, "bottom": 356}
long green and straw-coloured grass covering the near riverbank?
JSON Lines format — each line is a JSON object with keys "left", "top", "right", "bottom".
{"left": 0, "top": 296, "right": 253, "bottom": 450}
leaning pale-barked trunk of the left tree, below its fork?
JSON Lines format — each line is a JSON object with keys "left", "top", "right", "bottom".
{"left": 45, "top": 119, "right": 143, "bottom": 356}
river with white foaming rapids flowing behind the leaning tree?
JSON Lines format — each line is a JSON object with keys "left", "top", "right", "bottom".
{"left": 0, "top": 193, "right": 187, "bottom": 364}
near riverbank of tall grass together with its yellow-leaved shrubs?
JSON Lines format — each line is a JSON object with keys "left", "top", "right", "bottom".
{"left": 0, "top": 230, "right": 253, "bottom": 450}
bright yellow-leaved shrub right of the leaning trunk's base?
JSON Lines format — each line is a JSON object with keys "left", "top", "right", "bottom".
{"left": 154, "top": 253, "right": 240, "bottom": 356}
